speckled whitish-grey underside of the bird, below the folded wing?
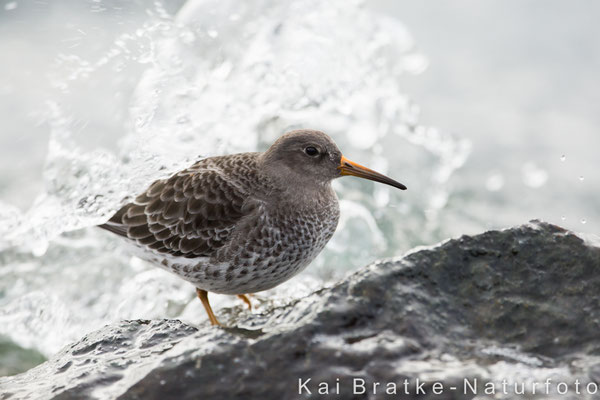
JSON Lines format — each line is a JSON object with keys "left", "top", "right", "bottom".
{"left": 160, "top": 203, "right": 339, "bottom": 294}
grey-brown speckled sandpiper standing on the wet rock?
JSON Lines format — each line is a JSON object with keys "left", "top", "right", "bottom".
{"left": 99, "top": 129, "right": 406, "bottom": 325}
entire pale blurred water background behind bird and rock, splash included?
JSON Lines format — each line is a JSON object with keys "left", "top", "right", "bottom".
{"left": 0, "top": 0, "right": 600, "bottom": 375}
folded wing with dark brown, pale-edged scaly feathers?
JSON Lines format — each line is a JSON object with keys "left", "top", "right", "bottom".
{"left": 100, "top": 162, "right": 252, "bottom": 258}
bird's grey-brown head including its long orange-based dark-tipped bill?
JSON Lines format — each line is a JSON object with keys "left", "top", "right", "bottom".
{"left": 263, "top": 130, "right": 406, "bottom": 190}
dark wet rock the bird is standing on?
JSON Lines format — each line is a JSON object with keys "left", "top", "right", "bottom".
{"left": 0, "top": 222, "right": 600, "bottom": 399}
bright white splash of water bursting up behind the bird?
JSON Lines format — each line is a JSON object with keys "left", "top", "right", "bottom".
{"left": 0, "top": 0, "right": 468, "bottom": 362}
